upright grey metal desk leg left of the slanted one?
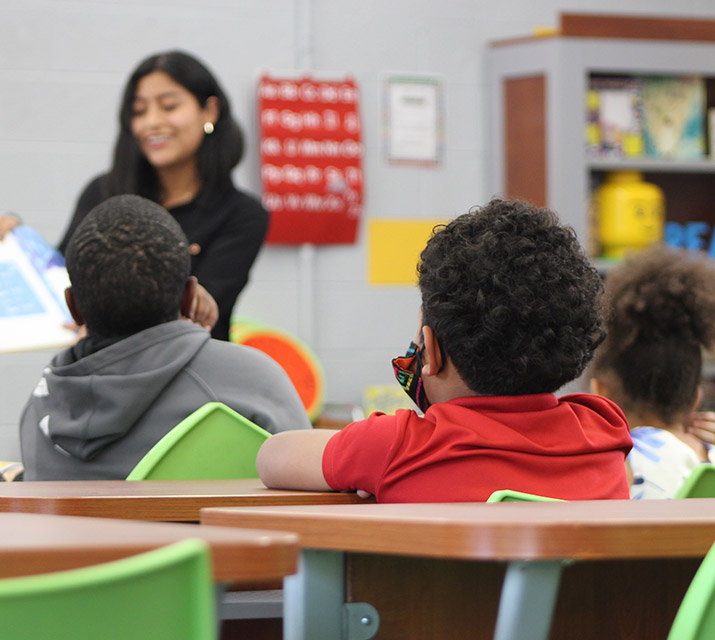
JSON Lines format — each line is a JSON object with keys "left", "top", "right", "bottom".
{"left": 283, "top": 549, "right": 345, "bottom": 640}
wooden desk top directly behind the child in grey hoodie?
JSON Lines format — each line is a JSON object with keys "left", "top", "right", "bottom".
{"left": 0, "top": 479, "right": 365, "bottom": 522}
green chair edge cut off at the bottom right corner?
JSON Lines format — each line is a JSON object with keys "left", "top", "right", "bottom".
{"left": 668, "top": 545, "right": 715, "bottom": 640}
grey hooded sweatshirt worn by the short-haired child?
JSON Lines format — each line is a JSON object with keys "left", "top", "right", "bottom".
{"left": 20, "top": 320, "right": 310, "bottom": 480}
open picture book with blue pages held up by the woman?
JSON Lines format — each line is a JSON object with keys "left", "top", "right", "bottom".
{"left": 0, "top": 226, "right": 75, "bottom": 352}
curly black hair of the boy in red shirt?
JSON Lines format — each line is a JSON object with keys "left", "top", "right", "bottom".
{"left": 418, "top": 199, "right": 604, "bottom": 395}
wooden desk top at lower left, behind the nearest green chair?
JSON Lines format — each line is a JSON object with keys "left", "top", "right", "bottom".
{"left": 0, "top": 513, "right": 298, "bottom": 584}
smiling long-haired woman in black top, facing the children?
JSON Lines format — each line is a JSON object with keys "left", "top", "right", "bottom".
{"left": 59, "top": 51, "right": 269, "bottom": 340}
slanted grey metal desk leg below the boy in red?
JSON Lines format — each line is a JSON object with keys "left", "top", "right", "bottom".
{"left": 494, "top": 561, "right": 561, "bottom": 640}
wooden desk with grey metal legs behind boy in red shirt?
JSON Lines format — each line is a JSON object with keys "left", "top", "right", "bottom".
{"left": 201, "top": 499, "right": 715, "bottom": 640}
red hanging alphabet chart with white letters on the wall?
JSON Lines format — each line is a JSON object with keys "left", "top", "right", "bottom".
{"left": 258, "top": 75, "right": 363, "bottom": 244}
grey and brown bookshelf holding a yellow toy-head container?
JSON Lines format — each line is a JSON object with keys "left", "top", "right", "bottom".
{"left": 487, "top": 14, "right": 715, "bottom": 258}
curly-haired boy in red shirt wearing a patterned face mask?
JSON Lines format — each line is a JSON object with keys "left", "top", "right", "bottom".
{"left": 257, "top": 200, "right": 631, "bottom": 502}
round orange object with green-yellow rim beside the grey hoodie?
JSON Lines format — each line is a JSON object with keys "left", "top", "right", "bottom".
{"left": 229, "top": 318, "right": 325, "bottom": 422}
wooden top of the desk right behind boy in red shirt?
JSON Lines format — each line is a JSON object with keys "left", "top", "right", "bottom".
{"left": 201, "top": 498, "right": 715, "bottom": 560}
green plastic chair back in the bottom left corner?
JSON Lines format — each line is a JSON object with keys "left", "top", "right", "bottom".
{"left": 0, "top": 540, "right": 217, "bottom": 640}
